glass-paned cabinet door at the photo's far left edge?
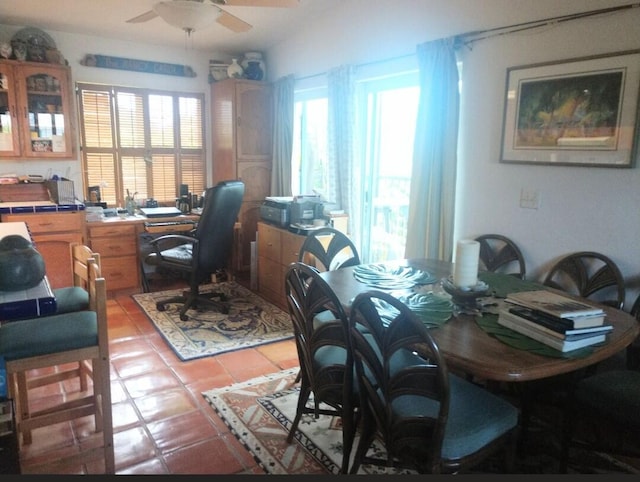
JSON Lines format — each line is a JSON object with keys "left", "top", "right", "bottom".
{"left": 0, "top": 64, "right": 20, "bottom": 157}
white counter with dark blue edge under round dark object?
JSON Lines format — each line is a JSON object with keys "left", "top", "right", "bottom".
{"left": 0, "top": 223, "right": 56, "bottom": 323}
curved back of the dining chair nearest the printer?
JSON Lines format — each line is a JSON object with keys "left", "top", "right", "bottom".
{"left": 298, "top": 226, "right": 360, "bottom": 271}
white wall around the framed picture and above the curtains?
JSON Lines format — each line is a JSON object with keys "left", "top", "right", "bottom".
{"left": 267, "top": 0, "right": 640, "bottom": 309}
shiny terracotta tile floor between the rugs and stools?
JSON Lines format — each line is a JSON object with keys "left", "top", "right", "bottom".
{"left": 21, "top": 282, "right": 298, "bottom": 474}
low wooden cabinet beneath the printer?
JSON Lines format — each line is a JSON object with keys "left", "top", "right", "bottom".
{"left": 257, "top": 222, "right": 305, "bottom": 310}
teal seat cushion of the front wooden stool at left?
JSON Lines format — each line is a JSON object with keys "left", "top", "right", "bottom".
{"left": 0, "top": 311, "right": 98, "bottom": 361}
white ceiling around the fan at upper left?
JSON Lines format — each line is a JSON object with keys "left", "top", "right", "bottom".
{"left": 0, "top": 0, "right": 345, "bottom": 52}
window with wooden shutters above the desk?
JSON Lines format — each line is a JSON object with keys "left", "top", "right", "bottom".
{"left": 76, "top": 83, "right": 206, "bottom": 207}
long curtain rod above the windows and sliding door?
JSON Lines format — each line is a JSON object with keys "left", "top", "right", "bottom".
{"left": 296, "top": 2, "right": 640, "bottom": 80}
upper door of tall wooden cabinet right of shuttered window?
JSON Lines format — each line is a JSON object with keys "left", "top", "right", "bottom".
{"left": 236, "top": 81, "right": 272, "bottom": 161}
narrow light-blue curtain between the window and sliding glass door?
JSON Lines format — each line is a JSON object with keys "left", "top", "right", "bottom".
{"left": 327, "top": 65, "right": 362, "bottom": 241}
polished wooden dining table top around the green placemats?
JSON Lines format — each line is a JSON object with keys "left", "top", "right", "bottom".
{"left": 321, "top": 259, "right": 639, "bottom": 382}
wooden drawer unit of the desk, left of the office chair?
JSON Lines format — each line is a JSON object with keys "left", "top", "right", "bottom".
{"left": 88, "top": 223, "right": 140, "bottom": 292}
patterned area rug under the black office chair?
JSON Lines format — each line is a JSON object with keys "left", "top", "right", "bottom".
{"left": 132, "top": 281, "right": 293, "bottom": 360}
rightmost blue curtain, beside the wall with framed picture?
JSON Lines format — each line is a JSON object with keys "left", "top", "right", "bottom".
{"left": 405, "top": 39, "right": 460, "bottom": 261}
